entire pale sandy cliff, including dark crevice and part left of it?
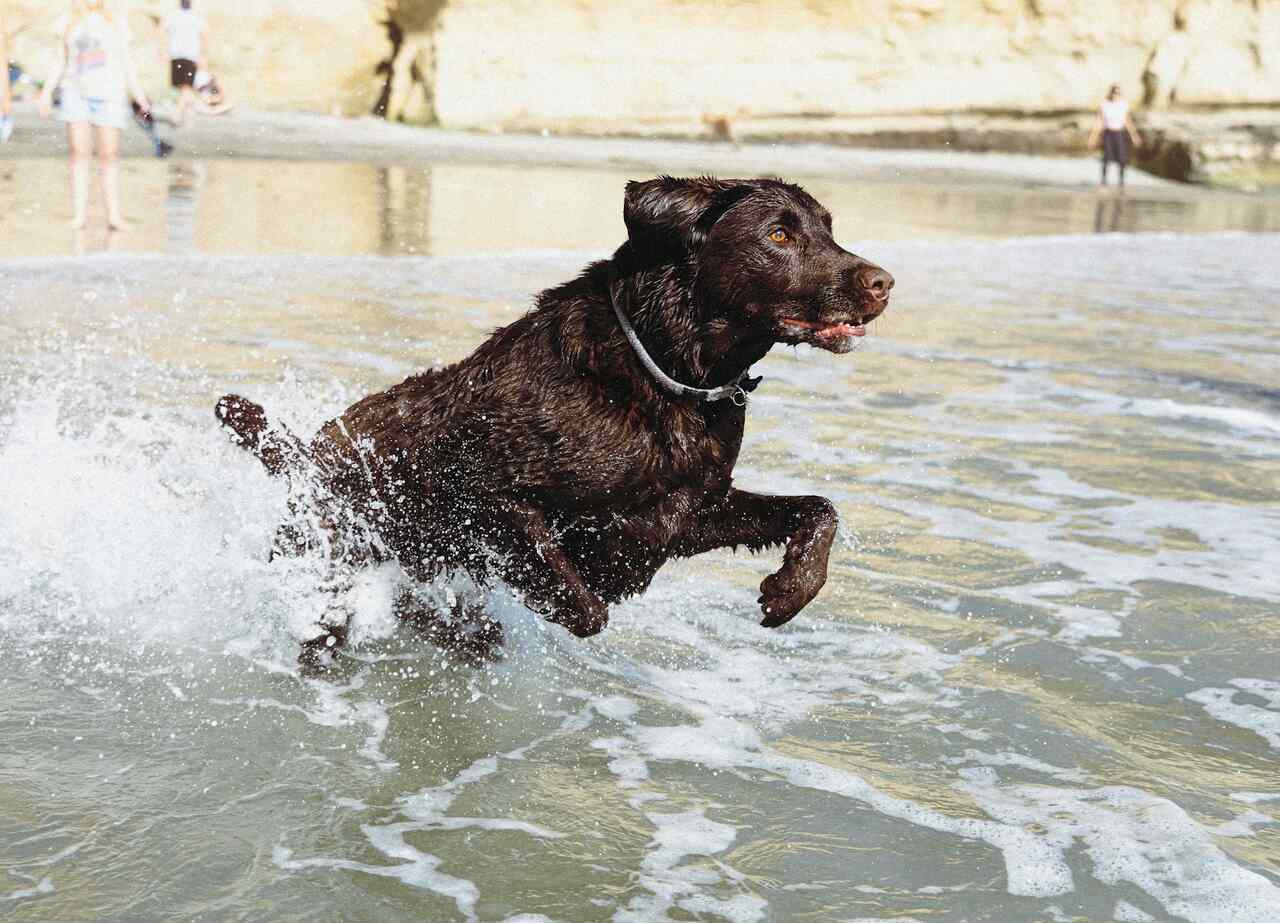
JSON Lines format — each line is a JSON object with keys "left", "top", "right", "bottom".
{"left": 6, "top": 0, "right": 1280, "bottom": 124}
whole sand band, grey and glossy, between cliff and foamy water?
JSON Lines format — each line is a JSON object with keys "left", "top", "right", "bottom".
{"left": 0, "top": 105, "right": 1280, "bottom": 257}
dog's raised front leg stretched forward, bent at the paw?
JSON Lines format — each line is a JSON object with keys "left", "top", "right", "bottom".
{"left": 676, "top": 490, "right": 838, "bottom": 629}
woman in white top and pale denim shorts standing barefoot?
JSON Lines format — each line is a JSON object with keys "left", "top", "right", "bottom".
{"left": 40, "top": 0, "right": 151, "bottom": 230}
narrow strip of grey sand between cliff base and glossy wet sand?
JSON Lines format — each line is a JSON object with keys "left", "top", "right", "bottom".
{"left": 0, "top": 102, "right": 1240, "bottom": 198}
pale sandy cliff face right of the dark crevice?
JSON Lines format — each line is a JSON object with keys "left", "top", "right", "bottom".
{"left": 414, "top": 0, "right": 1280, "bottom": 128}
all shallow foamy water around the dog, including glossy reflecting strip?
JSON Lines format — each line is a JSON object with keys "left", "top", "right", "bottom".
{"left": 0, "top": 161, "right": 1280, "bottom": 923}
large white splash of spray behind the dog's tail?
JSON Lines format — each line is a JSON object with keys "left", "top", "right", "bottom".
{"left": 0, "top": 398, "right": 308, "bottom": 644}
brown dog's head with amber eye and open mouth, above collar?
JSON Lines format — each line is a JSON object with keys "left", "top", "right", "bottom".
{"left": 622, "top": 177, "right": 893, "bottom": 352}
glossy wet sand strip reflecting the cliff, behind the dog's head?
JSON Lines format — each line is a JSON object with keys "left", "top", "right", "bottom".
{"left": 0, "top": 154, "right": 1280, "bottom": 256}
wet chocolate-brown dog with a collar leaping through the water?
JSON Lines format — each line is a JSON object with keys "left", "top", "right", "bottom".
{"left": 216, "top": 177, "right": 893, "bottom": 666}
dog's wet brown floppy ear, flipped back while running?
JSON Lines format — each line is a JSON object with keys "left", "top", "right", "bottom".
{"left": 622, "top": 177, "right": 751, "bottom": 252}
